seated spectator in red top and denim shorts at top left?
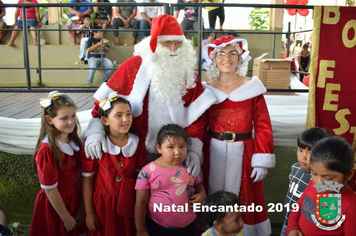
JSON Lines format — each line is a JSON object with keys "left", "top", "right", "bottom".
{"left": 7, "top": 0, "right": 42, "bottom": 46}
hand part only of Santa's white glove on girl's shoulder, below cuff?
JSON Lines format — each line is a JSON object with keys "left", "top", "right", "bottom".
{"left": 84, "top": 133, "right": 108, "bottom": 159}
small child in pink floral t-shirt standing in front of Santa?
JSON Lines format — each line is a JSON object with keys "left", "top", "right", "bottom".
{"left": 135, "top": 124, "right": 206, "bottom": 236}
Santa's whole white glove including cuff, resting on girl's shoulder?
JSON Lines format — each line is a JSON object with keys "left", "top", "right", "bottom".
{"left": 82, "top": 118, "right": 108, "bottom": 159}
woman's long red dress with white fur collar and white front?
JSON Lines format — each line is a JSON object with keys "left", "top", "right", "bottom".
{"left": 203, "top": 77, "right": 275, "bottom": 236}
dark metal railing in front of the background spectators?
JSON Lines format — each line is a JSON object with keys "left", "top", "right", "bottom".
{"left": 0, "top": 3, "right": 314, "bottom": 92}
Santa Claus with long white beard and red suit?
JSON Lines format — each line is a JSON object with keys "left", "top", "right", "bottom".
{"left": 83, "top": 15, "right": 216, "bottom": 176}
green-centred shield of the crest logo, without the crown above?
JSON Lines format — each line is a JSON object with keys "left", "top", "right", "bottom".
{"left": 315, "top": 193, "right": 341, "bottom": 225}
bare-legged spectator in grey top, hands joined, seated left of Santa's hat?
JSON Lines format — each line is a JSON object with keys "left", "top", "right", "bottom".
{"left": 112, "top": 0, "right": 140, "bottom": 46}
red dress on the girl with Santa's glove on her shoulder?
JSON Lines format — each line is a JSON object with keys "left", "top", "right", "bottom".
{"left": 82, "top": 133, "right": 147, "bottom": 236}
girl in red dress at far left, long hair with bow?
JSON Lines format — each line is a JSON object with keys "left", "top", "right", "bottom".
{"left": 30, "top": 91, "right": 84, "bottom": 236}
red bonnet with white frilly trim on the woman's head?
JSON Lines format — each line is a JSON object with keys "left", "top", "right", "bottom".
{"left": 202, "top": 36, "right": 251, "bottom": 71}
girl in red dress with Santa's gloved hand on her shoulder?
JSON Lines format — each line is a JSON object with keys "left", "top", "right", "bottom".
{"left": 82, "top": 92, "right": 147, "bottom": 236}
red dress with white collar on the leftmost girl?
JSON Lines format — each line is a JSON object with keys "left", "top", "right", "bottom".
{"left": 30, "top": 138, "right": 82, "bottom": 236}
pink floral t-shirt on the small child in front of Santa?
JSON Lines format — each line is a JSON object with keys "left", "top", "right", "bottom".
{"left": 135, "top": 162, "right": 201, "bottom": 228}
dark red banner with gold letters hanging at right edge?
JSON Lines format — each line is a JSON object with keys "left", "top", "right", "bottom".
{"left": 307, "top": 6, "right": 356, "bottom": 149}
